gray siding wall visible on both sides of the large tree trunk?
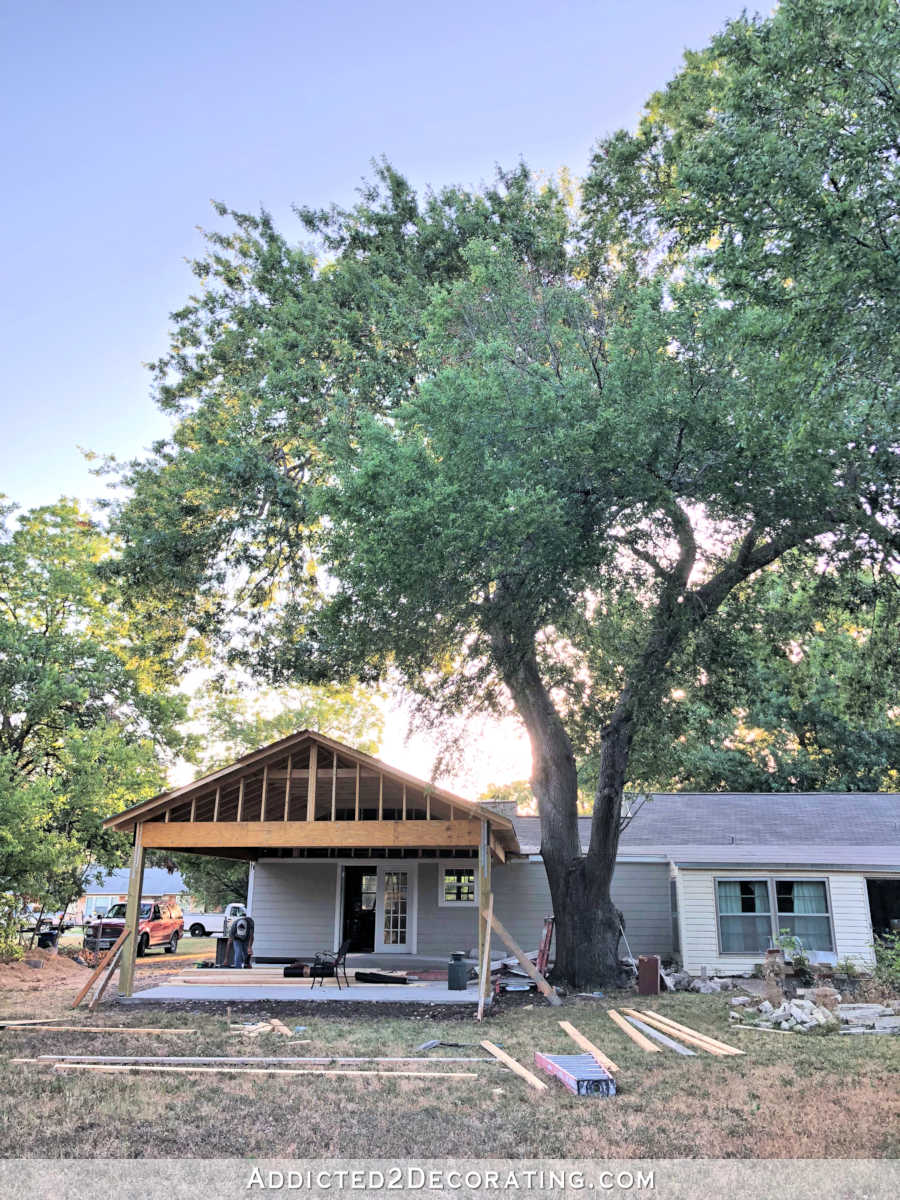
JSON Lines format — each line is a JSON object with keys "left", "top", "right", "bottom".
{"left": 489, "top": 862, "right": 672, "bottom": 958}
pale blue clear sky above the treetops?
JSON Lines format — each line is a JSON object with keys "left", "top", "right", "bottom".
{"left": 0, "top": 0, "right": 742, "bottom": 506}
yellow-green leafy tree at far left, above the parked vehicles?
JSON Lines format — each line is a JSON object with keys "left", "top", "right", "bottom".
{"left": 0, "top": 500, "right": 184, "bottom": 907}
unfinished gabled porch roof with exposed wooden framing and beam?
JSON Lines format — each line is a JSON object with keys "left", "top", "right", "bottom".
{"left": 104, "top": 730, "right": 520, "bottom": 859}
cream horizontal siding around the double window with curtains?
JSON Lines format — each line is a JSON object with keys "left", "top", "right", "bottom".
{"left": 676, "top": 868, "right": 874, "bottom": 974}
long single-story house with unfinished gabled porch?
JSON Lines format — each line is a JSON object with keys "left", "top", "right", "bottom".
{"left": 107, "top": 730, "right": 900, "bottom": 995}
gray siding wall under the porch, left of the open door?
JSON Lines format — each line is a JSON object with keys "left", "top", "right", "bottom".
{"left": 252, "top": 859, "right": 337, "bottom": 959}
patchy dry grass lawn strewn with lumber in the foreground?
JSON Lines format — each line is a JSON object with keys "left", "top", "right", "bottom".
{"left": 0, "top": 984, "right": 900, "bottom": 1158}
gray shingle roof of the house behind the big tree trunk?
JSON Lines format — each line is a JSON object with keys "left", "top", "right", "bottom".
{"left": 504, "top": 792, "right": 900, "bottom": 870}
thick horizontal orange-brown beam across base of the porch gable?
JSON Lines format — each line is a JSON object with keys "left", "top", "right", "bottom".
{"left": 138, "top": 820, "right": 487, "bottom": 854}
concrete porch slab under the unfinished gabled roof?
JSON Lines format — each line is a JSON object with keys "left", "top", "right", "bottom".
{"left": 131, "top": 983, "right": 478, "bottom": 1004}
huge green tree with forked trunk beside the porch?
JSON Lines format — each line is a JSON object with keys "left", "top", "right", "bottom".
{"left": 120, "top": 2, "right": 898, "bottom": 986}
